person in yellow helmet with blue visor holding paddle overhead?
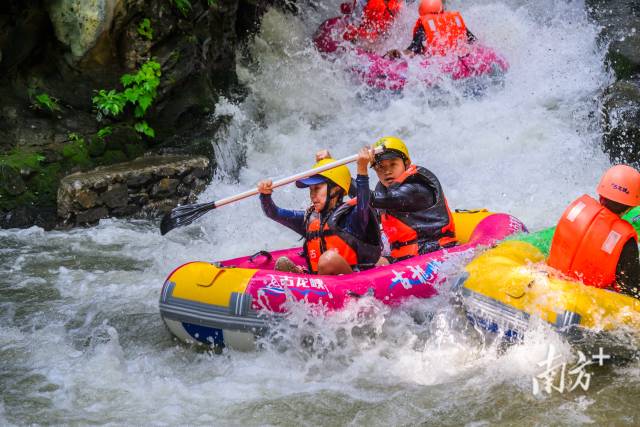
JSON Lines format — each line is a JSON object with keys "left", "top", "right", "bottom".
{"left": 258, "top": 149, "right": 382, "bottom": 275}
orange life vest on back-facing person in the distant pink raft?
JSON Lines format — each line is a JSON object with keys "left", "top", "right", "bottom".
{"left": 413, "top": 11, "right": 467, "bottom": 56}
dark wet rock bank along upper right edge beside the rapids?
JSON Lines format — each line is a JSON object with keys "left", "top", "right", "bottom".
{"left": 587, "top": 0, "right": 640, "bottom": 167}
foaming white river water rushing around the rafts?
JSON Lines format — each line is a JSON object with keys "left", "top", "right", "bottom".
{"left": 0, "top": 0, "right": 640, "bottom": 425}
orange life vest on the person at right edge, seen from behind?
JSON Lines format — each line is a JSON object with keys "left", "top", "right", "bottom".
{"left": 547, "top": 194, "right": 638, "bottom": 288}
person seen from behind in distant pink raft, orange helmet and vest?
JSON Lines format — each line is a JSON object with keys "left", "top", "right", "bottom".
{"left": 385, "top": 0, "right": 476, "bottom": 58}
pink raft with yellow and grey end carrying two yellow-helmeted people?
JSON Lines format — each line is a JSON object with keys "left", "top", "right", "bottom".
{"left": 160, "top": 210, "right": 524, "bottom": 350}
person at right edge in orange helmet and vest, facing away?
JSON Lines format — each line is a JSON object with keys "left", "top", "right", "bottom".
{"left": 547, "top": 165, "right": 640, "bottom": 298}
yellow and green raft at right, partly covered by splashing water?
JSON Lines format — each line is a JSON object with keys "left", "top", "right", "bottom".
{"left": 456, "top": 208, "right": 640, "bottom": 339}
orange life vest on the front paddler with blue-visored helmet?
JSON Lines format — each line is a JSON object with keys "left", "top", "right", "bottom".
{"left": 304, "top": 199, "right": 382, "bottom": 273}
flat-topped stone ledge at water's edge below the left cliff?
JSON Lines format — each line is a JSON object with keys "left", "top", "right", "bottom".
{"left": 58, "top": 155, "right": 210, "bottom": 226}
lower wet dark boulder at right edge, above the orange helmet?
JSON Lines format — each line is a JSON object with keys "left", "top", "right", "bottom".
{"left": 603, "top": 78, "right": 640, "bottom": 167}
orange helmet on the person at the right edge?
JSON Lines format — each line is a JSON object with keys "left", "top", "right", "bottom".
{"left": 597, "top": 165, "right": 640, "bottom": 206}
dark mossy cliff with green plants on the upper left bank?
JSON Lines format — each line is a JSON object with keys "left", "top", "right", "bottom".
{"left": 0, "top": 0, "right": 279, "bottom": 228}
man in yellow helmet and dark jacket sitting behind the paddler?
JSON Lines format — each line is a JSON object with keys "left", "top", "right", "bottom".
{"left": 316, "top": 136, "right": 457, "bottom": 265}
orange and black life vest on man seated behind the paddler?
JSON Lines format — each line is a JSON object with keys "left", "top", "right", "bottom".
{"left": 376, "top": 165, "right": 457, "bottom": 260}
